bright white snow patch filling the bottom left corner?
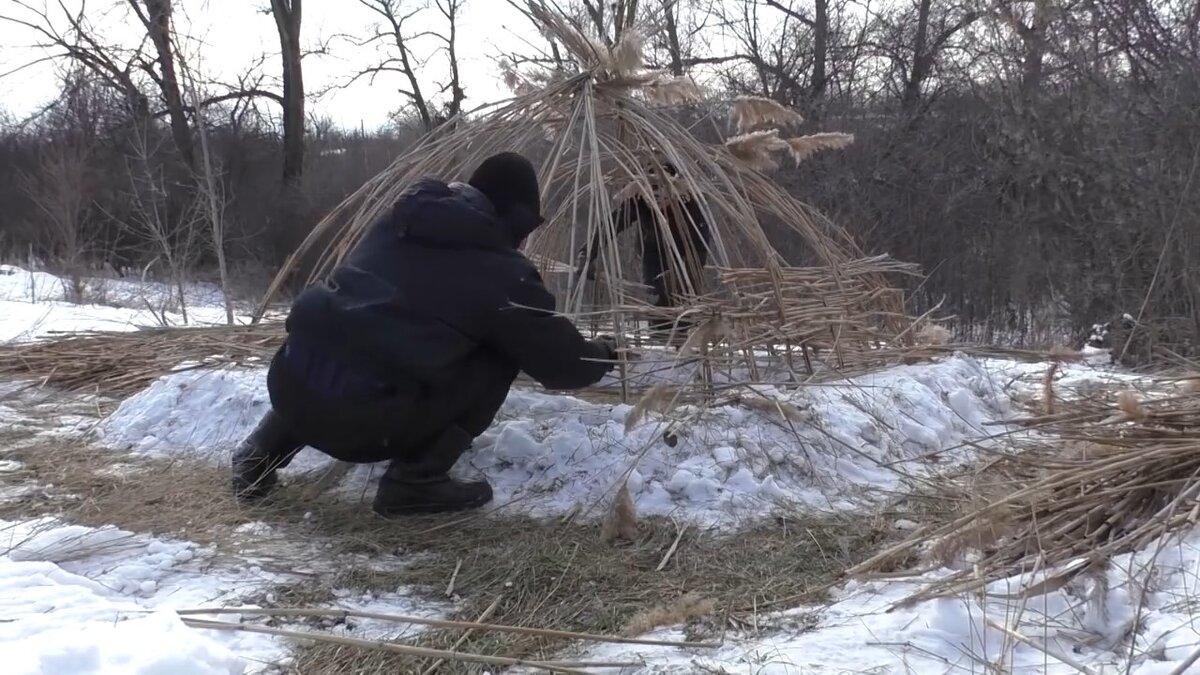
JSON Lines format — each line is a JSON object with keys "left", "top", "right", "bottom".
{"left": 0, "top": 518, "right": 287, "bottom": 675}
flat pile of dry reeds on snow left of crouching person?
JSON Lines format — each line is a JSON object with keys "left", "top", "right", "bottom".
{"left": 0, "top": 323, "right": 283, "bottom": 396}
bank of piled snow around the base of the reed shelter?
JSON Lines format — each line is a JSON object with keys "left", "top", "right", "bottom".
{"left": 100, "top": 356, "right": 1009, "bottom": 524}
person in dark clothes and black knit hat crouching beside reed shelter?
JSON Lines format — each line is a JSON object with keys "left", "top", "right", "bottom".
{"left": 233, "top": 153, "right": 614, "bottom": 516}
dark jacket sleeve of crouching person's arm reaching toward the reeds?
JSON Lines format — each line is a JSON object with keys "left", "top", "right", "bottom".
{"left": 488, "top": 270, "right": 614, "bottom": 389}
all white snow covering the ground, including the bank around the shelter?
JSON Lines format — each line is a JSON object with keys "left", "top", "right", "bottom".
{"left": 0, "top": 268, "right": 1200, "bottom": 675}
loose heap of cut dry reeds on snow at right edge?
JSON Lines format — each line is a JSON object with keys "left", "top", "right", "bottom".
{"left": 847, "top": 372, "right": 1200, "bottom": 604}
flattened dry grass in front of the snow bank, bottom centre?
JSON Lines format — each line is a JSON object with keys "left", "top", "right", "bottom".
{"left": 296, "top": 513, "right": 888, "bottom": 673}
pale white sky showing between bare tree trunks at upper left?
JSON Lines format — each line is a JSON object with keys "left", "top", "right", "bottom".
{"left": 0, "top": 0, "right": 540, "bottom": 130}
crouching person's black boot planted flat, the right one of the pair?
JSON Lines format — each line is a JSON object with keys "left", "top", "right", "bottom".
{"left": 373, "top": 426, "right": 492, "bottom": 518}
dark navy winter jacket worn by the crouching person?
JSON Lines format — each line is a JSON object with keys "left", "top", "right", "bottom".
{"left": 276, "top": 174, "right": 613, "bottom": 389}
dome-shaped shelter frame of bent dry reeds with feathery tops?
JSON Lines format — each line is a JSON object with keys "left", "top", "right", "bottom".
{"left": 264, "top": 0, "right": 914, "bottom": 396}
